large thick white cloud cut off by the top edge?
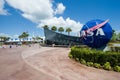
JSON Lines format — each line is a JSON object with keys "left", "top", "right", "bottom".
{"left": 6, "top": 0, "right": 53, "bottom": 22}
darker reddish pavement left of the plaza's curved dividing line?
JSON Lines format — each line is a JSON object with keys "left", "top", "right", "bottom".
{"left": 0, "top": 46, "right": 56, "bottom": 80}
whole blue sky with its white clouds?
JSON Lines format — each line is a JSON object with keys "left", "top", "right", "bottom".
{"left": 0, "top": 0, "right": 120, "bottom": 37}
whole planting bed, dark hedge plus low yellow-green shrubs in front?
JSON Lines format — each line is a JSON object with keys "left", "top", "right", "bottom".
{"left": 69, "top": 47, "right": 120, "bottom": 72}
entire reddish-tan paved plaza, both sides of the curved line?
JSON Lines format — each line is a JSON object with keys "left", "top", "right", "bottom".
{"left": 0, "top": 46, "right": 120, "bottom": 80}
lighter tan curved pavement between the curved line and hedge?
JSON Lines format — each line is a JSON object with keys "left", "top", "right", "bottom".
{"left": 22, "top": 48, "right": 120, "bottom": 80}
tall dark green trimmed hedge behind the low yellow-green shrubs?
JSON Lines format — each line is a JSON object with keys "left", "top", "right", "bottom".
{"left": 70, "top": 47, "right": 120, "bottom": 67}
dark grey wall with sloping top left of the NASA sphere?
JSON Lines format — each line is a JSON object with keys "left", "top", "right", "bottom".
{"left": 44, "top": 29, "right": 82, "bottom": 45}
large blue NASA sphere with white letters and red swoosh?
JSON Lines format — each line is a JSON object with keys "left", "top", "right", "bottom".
{"left": 80, "top": 19, "right": 112, "bottom": 48}
